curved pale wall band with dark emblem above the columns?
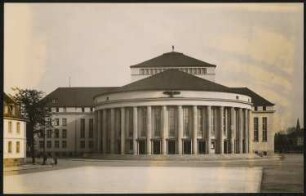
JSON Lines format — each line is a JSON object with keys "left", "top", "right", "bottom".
{"left": 95, "top": 91, "right": 251, "bottom": 110}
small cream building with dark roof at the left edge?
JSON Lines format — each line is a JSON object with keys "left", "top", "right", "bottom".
{"left": 3, "top": 93, "right": 26, "bottom": 166}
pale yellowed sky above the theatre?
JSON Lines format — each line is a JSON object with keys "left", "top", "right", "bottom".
{"left": 4, "top": 3, "right": 304, "bottom": 131}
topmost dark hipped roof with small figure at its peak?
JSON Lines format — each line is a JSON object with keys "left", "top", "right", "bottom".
{"left": 130, "top": 52, "right": 216, "bottom": 68}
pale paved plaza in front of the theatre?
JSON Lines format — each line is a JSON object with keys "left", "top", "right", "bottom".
{"left": 4, "top": 155, "right": 304, "bottom": 193}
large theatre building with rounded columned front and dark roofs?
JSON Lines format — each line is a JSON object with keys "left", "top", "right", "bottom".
{"left": 37, "top": 52, "right": 274, "bottom": 155}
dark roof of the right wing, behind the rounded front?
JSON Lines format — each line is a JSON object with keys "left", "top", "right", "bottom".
{"left": 231, "top": 87, "right": 274, "bottom": 106}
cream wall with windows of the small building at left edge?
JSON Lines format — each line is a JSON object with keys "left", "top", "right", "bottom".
{"left": 3, "top": 118, "right": 26, "bottom": 159}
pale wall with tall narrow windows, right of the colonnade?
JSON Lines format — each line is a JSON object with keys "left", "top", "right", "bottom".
{"left": 250, "top": 107, "right": 275, "bottom": 153}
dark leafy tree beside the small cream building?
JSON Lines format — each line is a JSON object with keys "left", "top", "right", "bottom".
{"left": 13, "top": 88, "right": 51, "bottom": 164}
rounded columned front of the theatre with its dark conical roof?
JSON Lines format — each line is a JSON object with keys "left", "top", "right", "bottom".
{"left": 94, "top": 69, "right": 252, "bottom": 155}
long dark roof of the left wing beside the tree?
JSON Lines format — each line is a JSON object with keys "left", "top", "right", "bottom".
{"left": 44, "top": 87, "right": 116, "bottom": 107}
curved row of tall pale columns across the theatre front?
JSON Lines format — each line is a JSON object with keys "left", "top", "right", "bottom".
{"left": 95, "top": 105, "right": 250, "bottom": 155}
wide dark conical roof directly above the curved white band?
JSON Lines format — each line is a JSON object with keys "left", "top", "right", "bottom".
{"left": 103, "top": 69, "right": 237, "bottom": 94}
